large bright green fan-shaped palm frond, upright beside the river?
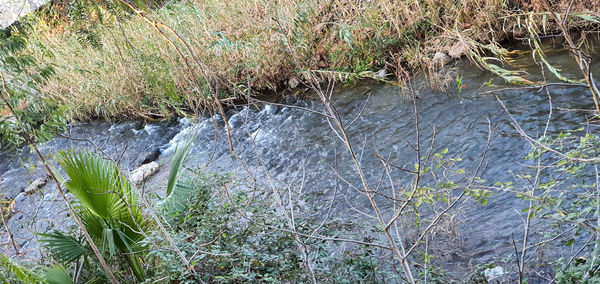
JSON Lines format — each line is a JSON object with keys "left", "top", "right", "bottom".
{"left": 56, "top": 151, "right": 148, "bottom": 280}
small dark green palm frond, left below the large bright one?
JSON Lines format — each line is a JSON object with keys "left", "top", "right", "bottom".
{"left": 38, "top": 231, "right": 90, "bottom": 264}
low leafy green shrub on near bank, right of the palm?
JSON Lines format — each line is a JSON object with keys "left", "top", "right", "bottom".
{"left": 145, "top": 172, "right": 389, "bottom": 283}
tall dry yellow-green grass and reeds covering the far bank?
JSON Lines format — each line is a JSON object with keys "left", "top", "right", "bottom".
{"left": 2, "top": 0, "right": 600, "bottom": 120}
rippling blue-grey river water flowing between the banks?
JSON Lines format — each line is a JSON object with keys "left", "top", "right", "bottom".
{"left": 0, "top": 43, "right": 599, "bottom": 276}
